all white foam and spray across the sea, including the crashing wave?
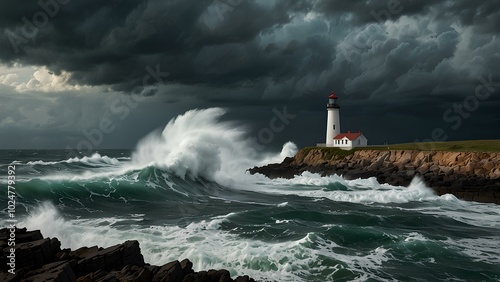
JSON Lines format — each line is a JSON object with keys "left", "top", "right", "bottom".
{"left": 6, "top": 109, "right": 500, "bottom": 281}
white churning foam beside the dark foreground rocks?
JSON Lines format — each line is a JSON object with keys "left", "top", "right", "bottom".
{"left": 15, "top": 204, "right": 400, "bottom": 281}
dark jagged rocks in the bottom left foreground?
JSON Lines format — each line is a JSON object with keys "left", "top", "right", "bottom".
{"left": 0, "top": 229, "right": 254, "bottom": 282}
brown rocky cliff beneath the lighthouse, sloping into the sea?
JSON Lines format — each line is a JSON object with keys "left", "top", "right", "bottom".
{"left": 249, "top": 148, "right": 500, "bottom": 204}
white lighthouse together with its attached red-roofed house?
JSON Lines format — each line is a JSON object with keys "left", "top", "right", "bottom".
{"left": 325, "top": 91, "right": 368, "bottom": 150}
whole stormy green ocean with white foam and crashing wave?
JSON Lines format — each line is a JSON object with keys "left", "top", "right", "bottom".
{"left": 0, "top": 109, "right": 500, "bottom": 281}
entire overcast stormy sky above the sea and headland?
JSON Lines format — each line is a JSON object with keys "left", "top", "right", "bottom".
{"left": 0, "top": 0, "right": 500, "bottom": 152}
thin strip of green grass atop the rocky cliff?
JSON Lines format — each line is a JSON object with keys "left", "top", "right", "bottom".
{"left": 302, "top": 140, "right": 500, "bottom": 154}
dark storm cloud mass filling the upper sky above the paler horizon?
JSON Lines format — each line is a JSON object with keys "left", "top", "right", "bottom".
{"left": 0, "top": 0, "right": 500, "bottom": 145}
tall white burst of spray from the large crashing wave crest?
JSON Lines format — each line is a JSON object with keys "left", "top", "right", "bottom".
{"left": 132, "top": 108, "right": 297, "bottom": 183}
